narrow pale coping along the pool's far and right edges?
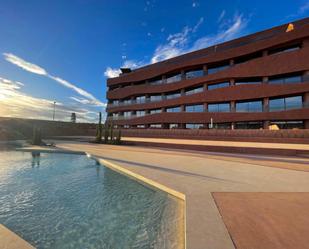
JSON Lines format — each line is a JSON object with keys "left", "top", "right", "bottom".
{"left": 10, "top": 146, "right": 187, "bottom": 249}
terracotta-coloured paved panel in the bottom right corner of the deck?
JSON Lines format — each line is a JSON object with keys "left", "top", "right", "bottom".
{"left": 213, "top": 193, "right": 309, "bottom": 249}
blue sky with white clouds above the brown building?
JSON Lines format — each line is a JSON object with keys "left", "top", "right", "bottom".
{"left": 0, "top": 0, "right": 309, "bottom": 122}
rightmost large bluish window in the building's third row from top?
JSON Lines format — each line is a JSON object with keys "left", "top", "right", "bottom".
{"left": 269, "top": 96, "right": 303, "bottom": 111}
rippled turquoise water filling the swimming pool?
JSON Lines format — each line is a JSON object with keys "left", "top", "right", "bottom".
{"left": 0, "top": 151, "right": 182, "bottom": 249}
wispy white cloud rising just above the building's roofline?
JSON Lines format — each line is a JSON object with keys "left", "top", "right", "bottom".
{"left": 104, "top": 13, "right": 248, "bottom": 78}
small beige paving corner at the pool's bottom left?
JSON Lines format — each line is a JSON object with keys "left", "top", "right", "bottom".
{"left": 0, "top": 224, "right": 35, "bottom": 249}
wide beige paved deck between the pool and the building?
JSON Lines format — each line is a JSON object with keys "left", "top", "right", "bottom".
{"left": 56, "top": 141, "right": 309, "bottom": 249}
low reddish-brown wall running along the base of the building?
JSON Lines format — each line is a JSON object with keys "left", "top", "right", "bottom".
{"left": 122, "top": 129, "right": 309, "bottom": 144}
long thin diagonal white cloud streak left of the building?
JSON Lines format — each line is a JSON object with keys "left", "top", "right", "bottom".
{"left": 3, "top": 53, "right": 105, "bottom": 106}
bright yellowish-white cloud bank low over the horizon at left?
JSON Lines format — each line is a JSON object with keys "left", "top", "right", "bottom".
{"left": 0, "top": 77, "right": 96, "bottom": 122}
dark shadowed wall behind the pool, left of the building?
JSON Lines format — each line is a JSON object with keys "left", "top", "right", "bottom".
{"left": 0, "top": 117, "right": 96, "bottom": 140}
